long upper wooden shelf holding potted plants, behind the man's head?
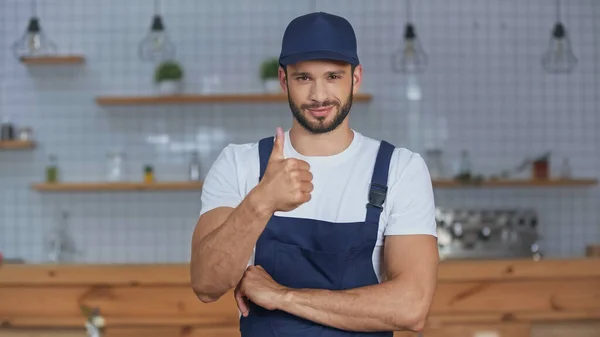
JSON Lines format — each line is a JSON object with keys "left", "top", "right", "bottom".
{"left": 96, "top": 93, "right": 372, "bottom": 105}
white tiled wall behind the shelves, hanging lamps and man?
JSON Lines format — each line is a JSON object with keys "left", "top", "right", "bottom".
{"left": 0, "top": 0, "right": 600, "bottom": 262}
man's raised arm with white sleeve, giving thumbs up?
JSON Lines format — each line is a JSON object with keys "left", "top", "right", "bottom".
{"left": 190, "top": 128, "right": 313, "bottom": 303}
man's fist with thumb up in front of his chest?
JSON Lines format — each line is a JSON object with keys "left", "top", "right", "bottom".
{"left": 259, "top": 128, "right": 313, "bottom": 212}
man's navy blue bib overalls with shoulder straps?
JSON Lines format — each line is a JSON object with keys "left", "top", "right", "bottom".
{"left": 240, "top": 137, "right": 394, "bottom": 337}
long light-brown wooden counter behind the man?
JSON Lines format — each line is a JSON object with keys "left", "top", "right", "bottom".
{"left": 0, "top": 258, "right": 600, "bottom": 337}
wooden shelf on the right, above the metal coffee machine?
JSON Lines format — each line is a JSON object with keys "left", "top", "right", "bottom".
{"left": 433, "top": 179, "right": 598, "bottom": 188}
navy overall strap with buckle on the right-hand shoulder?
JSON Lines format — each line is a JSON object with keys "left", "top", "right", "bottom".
{"left": 366, "top": 140, "right": 394, "bottom": 225}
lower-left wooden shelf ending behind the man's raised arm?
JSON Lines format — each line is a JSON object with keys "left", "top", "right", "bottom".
{"left": 32, "top": 181, "right": 202, "bottom": 192}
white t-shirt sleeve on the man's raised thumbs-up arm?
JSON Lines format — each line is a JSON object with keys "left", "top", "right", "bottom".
{"left": 200, "top": 145, "right": 243, "bottom": 215}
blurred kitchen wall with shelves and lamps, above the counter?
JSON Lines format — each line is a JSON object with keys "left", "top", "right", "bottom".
{"left": 0, "top": 0, "right": 600, "bottom": 336}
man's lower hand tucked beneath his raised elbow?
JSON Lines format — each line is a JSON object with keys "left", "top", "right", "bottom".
{"left": 235, "top": 266, "right": 288, "bottom": 317}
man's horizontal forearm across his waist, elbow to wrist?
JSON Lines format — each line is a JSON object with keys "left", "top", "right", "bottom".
{"left": 279, "top": 280, "right": 430, "bottom": 331}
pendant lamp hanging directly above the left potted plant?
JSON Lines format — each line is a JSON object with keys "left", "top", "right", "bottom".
{"left": 138, "top": 0, "right": 175, "bottom": 62}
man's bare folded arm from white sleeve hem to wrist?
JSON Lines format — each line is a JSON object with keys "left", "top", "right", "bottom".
{"left": 277, "top": 235, "right": 439, "bottom": 332}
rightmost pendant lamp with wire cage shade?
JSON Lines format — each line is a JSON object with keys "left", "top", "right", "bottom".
{"left": 542, "top": 0, "right": 578, "bottom": 74}
